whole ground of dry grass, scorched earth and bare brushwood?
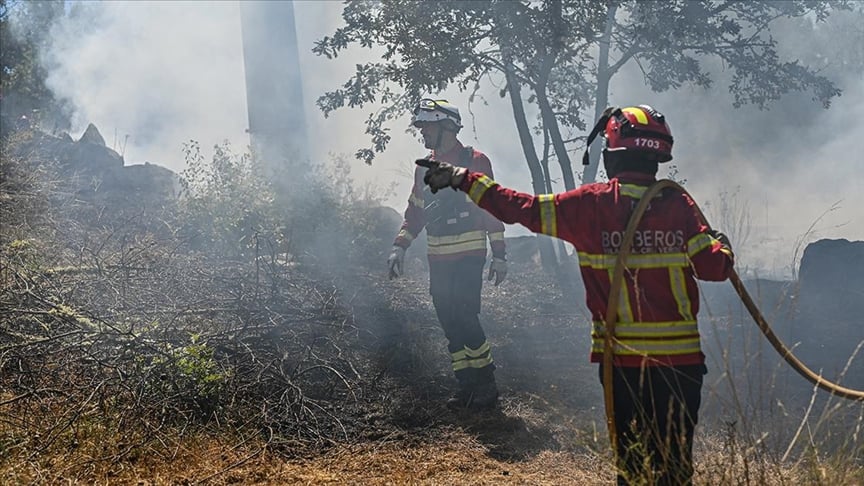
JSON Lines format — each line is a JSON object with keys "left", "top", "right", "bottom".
{"left": 0, "top": 135, "right": 864, "bottom": 486}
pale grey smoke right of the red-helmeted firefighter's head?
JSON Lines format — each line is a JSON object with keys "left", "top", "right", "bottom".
{"left": 611, "top": 12, "right": 864, "bottom": 278}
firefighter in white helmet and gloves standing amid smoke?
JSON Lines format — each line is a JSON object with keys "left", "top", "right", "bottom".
{"left": 388, "top": 99, "right": 507, "bottom": 410}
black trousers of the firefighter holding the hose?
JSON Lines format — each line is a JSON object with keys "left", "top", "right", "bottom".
{"left": 600, "top": 365, "right": 707, "bottom": 486}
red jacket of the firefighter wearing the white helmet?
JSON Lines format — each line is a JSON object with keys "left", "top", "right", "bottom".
{"left": 394, "top": 143, "right": 505, "bottom": 262}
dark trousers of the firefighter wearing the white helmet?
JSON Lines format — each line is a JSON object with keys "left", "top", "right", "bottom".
{"left": 429, "top": 257, "right": 495, "bottom": 387}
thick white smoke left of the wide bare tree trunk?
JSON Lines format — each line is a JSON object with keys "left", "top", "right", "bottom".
{"left": 47, "top": 2, "right": 248, "bottom": 164}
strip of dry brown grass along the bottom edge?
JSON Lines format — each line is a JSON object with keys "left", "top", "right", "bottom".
{"left": 0, "top": 418, "right": 864, "bottom": 486}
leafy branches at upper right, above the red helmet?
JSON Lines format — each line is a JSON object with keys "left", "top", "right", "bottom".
{"left": 610, "top": 1, "right": 845, "bottom": 108}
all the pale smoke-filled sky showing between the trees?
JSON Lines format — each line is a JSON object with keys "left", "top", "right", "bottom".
{"left": 49, "top": 1, "right": 864, "bottom": 276}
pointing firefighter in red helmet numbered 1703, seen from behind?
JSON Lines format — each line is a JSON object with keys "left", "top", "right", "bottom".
{"left": 418, "top": 105, "right": 733, "bottom": 485}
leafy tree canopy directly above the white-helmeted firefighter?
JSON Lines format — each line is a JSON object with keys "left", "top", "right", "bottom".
{"left": 313, "top": 0, "right": 603, "bottom": 167}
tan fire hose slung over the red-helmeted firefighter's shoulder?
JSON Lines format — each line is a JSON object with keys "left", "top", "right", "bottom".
{"left": 603, "top": 179, "right": 864, "bottom": 457}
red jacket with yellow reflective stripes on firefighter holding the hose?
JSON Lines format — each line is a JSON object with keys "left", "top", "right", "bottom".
{"left": 460, "top": 172, "right": 733, "bottom": 366}
